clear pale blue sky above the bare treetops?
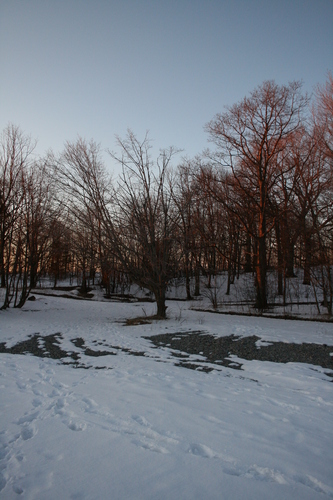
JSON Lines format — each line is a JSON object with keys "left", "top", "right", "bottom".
{"left": 0, "top": 0, "right": 333, "bottom": 172}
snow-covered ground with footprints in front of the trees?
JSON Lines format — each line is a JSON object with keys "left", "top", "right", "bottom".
{"left": 0, "top": 295, "right": 333, "bottom": 500}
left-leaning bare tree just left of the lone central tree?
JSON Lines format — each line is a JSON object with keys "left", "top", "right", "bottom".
{"left": 52, "top": 138, "right": 112, "bottom": 293}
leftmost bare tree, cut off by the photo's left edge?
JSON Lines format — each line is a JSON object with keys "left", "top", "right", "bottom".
{"left": 0, "top": 125, "right": 50, "bottom": 308}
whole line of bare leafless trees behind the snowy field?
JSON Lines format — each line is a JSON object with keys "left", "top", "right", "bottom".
{"left": 0, "top": 78, "right": 333, "bottom": 318}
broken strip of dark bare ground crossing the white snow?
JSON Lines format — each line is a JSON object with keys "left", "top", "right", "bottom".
{"left": 0, "top": 331, "right": 333, "bottom": 376}
